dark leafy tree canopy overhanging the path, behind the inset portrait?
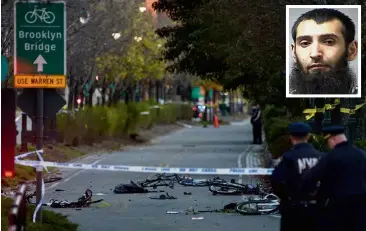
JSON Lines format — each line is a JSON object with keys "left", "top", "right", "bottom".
{"left": 153, "top": 0, "right": 366, "bottom": 111}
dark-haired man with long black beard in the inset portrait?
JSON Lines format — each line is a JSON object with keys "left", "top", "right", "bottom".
{"left": 289, "top": 8, "right": 358, "bottom": 94}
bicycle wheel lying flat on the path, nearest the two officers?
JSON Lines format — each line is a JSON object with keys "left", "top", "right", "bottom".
{"left": 236, "top": 200, "right": 279, "bottom": 215}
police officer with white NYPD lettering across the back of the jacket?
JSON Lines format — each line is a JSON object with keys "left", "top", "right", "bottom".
{"left": 271, "top": 122, "right": 325, "bottom": 231}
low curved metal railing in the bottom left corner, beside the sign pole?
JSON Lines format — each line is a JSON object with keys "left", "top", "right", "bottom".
{"left": 8, "top": 184, "right": 27, "bottom": 231}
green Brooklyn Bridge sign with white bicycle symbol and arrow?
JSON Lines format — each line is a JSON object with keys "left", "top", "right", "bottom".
{"left": 14, "top": 1, "right": 66, "bottom": 78}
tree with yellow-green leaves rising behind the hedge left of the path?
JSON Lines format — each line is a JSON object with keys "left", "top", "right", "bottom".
{"left": 96, "top": 4, "right": 166, "bottom": 102}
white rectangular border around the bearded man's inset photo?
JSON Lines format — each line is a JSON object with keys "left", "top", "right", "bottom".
{"left": 286, "top": 5, "right": 362, "bottom": 98}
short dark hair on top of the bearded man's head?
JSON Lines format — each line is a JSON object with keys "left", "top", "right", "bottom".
{"left": 291, "top": 8, "right": 356, "bottom": 45}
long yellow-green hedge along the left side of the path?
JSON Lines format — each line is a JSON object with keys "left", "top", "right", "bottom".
{"left": 57, "top": 102, "right": 193, "bottom": 146}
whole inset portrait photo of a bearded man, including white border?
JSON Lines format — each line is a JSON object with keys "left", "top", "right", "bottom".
{"left": 286, "top": 5, "right": 361, "bottom": 98}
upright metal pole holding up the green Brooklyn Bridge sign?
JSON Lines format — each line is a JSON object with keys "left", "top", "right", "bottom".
{"left": 36, "top": 88, "right": 44, "bottom": 223}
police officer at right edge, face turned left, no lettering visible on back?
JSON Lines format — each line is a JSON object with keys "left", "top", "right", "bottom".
{"left": 303, "top": 126, "right": 366, "bottom": 231}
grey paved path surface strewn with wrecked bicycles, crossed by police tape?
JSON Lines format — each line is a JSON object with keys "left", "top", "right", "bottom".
{"left": 40, "top": 122, "right": 280, "bottom": 231}
